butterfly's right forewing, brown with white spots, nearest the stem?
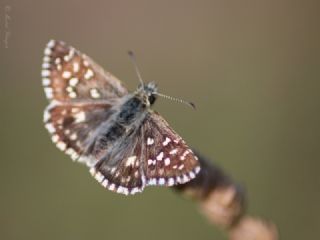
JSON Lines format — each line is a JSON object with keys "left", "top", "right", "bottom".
{"left": 142, "top": 113, "right": 200, "bottom": 186}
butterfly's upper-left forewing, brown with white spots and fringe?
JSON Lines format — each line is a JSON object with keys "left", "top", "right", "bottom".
{"left": 42, "top": 40, "right": 128, "bottom": 101}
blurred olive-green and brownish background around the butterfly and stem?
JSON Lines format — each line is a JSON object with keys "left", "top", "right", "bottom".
{"left": 0, "top": 0, "right": 320, "bottom": 240}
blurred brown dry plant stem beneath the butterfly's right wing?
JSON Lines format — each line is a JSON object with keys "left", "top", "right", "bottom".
{"left": 175, "top": 153, "right": 278, "bottom": 240}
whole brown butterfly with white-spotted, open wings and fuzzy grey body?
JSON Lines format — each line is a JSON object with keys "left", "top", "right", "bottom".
{"left": 41, "top": 40, "right": 200, "bottom": 195}
